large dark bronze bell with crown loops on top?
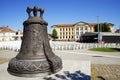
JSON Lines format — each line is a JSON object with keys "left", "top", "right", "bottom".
{"left": 7, "top": 6, "right": 62, "bottom": 77}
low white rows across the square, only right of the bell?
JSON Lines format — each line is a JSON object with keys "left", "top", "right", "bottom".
{"left": 51, "top": 42, "right": 120, "bottom": 50}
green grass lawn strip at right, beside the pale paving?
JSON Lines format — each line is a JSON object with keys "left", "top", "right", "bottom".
{"left": 88, "top": 48, "right": 120, "bottom": 52}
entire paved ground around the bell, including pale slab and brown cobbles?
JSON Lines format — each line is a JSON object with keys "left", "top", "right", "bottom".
{"left": 0, "top": 49, "right": 120, "bottom": 80}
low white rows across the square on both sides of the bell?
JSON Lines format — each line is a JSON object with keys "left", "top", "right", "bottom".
{"left": 0, "top": 41, "right": 120, "bottom": 51}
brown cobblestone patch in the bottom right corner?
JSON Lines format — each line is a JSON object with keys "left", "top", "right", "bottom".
{"left": 91, "top": 64, "right": 120, "bottom": 80}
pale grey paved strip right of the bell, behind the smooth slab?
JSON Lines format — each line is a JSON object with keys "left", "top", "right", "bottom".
{"left": 54, "top": 50, "right": 120, "bottom": 65}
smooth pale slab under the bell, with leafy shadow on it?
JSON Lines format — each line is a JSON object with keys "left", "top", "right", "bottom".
{"left": 0, "top": 60, "right": 91, "bottom": 80}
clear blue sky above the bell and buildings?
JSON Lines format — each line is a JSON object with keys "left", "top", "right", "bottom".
{"left": 0, "top": 0, "right": 120, "bottom": 33}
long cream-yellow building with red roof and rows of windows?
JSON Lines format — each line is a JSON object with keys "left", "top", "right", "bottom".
{"left": 52, "top": 22, "right": 113, "bottom": 41}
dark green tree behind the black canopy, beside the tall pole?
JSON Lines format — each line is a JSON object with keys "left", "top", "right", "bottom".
{"left": 94, "top": 23, "right": 111, "bottom": 32}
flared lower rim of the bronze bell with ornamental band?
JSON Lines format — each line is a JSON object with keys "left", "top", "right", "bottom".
{"left": 7, "top": 56, "right": 62, "bottom": 77}
